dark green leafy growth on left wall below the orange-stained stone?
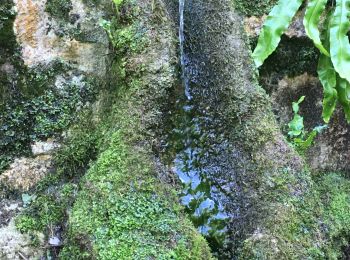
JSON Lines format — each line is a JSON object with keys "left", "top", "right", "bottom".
{"left": 0, "top": 61, "right": 95, "bottom": 171}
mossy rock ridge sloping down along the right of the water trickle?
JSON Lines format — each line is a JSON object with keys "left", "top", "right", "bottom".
{"left": 178, "top": 0, "right": 348, "bottom": 259}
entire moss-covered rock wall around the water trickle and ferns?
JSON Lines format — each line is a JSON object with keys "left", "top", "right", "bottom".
{"left": 0, "top": 0, "right": 350, "bottom": 259}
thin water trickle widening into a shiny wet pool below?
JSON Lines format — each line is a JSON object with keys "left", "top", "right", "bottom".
{"left": 167, "top": 0, "right": 234, "bottom": 251}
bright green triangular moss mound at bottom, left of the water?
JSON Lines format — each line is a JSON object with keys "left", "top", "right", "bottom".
{"left": 61, "top": 131, "right": 209, "bottom": 259}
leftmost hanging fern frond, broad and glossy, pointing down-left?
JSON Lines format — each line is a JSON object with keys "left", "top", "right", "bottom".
{"left": 252, "top": 0, "right": 303, "bottom": 67}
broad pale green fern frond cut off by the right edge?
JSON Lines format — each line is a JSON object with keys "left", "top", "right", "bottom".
{"left": 329, "top": 0, "right": 350, "bottom": 82}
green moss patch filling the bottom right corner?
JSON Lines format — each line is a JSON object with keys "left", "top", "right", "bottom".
{"left": 241, "top": 173, "right": 350, "bottom": 259}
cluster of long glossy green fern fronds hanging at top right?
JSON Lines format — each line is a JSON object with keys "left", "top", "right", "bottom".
{"left": 253, "top": 0, "right": 350, "bottom": 123}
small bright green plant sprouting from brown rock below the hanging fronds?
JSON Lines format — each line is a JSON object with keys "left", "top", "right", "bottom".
{"left": 288, "top": 96, "right": 327, "bottom": 152}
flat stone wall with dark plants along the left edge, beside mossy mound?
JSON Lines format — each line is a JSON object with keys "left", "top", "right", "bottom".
{"left": 0, "top": 0, "right": 112, "bottom": 259}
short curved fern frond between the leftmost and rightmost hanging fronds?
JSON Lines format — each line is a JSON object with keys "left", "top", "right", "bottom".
{"left": 304, "top": 0, "right": 329, "bottom": 56}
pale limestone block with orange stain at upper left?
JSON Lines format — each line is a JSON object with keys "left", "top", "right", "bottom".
{"left": 14, "top": 0, "right": 108, "bottom": 76}
